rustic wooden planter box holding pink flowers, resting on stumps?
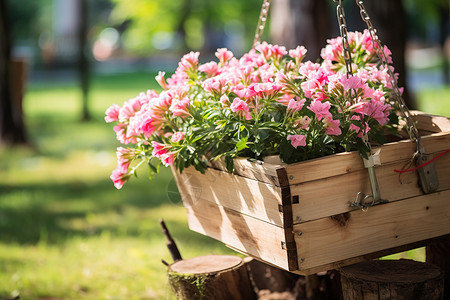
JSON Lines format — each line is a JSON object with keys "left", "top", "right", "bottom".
{"left": 173, "top": 112, "right": 450, "bottom": 274}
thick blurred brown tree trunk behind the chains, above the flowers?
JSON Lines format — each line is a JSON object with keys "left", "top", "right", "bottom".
{"left": 271, "top": 0, "right": 414, "bottom": 108}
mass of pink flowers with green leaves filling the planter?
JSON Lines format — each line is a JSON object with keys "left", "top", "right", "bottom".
{"left": 105, "top": 31, "right": 398, "bottom": 188}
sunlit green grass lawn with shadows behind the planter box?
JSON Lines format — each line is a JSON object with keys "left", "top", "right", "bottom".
{"left": 0, "top": 73, "right": 450, "bottom": 300}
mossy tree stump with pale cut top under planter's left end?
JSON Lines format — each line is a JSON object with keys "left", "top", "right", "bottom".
{"left": 168, "top": 255, "right": 256, "bottom": 300}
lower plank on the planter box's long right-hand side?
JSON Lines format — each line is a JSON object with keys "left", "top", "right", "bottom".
{"left": 294, "top": 190, "right": 450, "bottom": 271}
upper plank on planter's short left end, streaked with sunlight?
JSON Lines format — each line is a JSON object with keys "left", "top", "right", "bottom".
{"left": 174, "top": 168, "right": 284, "bottom": 227}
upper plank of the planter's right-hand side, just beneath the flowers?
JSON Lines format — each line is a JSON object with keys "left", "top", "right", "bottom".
{"left": 285, "top": 132, "right": 450, "bottom": 185}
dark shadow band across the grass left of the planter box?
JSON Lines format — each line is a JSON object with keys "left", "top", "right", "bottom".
{"left": 0, "top": 179, "right": 200, "bottom": 245}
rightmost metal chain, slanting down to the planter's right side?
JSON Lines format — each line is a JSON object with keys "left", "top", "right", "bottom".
{"left": 355, "top": 0, "right": 424, "bottom": 153}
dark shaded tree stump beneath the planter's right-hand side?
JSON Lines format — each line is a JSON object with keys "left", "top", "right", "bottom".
{"left": 340, "top": 259, "right": 444, "bottom": 300}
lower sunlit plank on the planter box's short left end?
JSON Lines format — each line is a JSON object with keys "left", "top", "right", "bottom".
{"left": 186, "top": 201, "right": 296, "bottom": 270}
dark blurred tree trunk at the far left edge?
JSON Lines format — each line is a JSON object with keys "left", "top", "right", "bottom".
{"left": 0, "top": 0, "right": 27, "bottom": 146}
